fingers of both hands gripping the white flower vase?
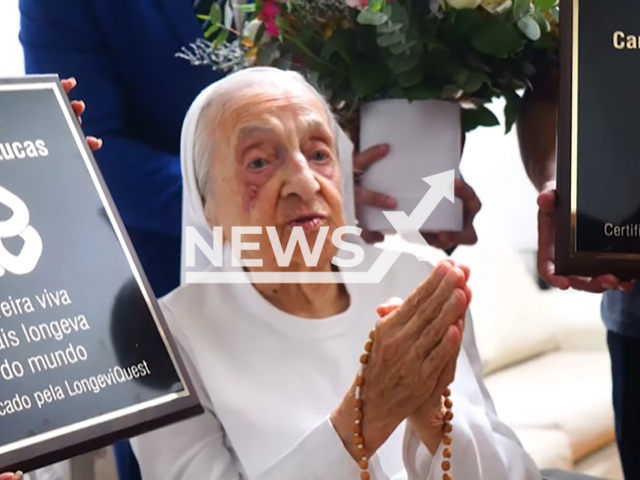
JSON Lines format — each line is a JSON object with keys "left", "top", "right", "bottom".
{"left": 353, "top": 145, "right": 482, "bottom": 250}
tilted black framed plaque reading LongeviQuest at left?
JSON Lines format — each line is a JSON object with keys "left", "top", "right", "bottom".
{"left": 0, "top": 76, "right": 202, "bottom": 472}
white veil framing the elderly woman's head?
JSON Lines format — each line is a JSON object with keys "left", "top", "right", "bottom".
{"left": 180, "top": 67, "right": 356, "bottom": 284}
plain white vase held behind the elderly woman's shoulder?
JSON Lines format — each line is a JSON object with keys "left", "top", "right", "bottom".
{"left": 358, "top": 99, "right": 463, "bottom": 233}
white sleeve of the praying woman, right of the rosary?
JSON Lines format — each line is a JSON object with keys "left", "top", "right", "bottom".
{"left": 404, "top": 316, "right": 540, "bottom": 480}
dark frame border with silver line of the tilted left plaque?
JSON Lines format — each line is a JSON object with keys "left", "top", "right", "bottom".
{"left": 0, "top": 74, "right": 204, "bottom": 472}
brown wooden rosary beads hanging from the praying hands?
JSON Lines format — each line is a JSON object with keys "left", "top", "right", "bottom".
{"left": 353, "top": 330, "right": 453, "bottom": 480}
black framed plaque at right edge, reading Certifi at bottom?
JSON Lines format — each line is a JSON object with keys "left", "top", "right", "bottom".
{"left": 556, "top": 0, "right": 640, "bottom": 279}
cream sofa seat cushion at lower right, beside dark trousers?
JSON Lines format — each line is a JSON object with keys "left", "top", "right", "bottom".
{"left": 485, "top": 351, "right": 615, "bottom": 461}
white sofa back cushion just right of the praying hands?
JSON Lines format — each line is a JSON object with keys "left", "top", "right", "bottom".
{"left": 453, "top": 213, "right": 558, "bottom": 374}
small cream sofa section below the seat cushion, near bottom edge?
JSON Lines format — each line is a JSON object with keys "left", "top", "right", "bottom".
{"left": 515, "top": 428, "right": 573, "bottom": 470}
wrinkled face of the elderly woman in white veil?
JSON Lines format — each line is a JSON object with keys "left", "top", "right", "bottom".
{"left": 205, "top": 85, "right": 345, "bottom": 270}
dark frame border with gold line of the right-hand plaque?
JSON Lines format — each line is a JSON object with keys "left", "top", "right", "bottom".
{"left": 555, "top": 0, "right": 640, "bottom": 280}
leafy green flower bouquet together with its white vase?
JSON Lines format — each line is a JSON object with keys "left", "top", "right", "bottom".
{"left": 179, "top": 0, "right": 558, "bottom": 230}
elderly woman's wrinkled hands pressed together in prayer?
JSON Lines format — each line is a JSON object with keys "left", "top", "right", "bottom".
{"left": 332, "top": 262, "right": 470, "bottom": 460}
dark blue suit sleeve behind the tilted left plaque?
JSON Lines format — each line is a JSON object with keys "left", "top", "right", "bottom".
{"left": 20, "top": 0, "right": 182, "bottom": 235}
